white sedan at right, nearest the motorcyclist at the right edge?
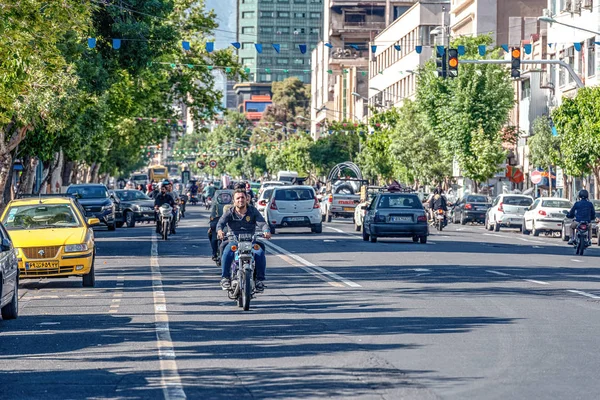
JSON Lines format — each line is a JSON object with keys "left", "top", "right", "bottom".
{"left": 521, "top": 197, "right": 573, "bottom": 236}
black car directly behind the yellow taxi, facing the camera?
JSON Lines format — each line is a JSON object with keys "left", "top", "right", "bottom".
{"left": 67, "top": 183, "right": 116, "bottom": 231}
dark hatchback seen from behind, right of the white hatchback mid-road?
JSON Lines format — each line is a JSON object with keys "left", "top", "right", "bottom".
{"left": 362, "top": 193, "right": 429, "bottom": 243}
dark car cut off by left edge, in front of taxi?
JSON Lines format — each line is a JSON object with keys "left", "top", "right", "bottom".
{"left": 0, "top": 224, "right": 19, "bottom": 319}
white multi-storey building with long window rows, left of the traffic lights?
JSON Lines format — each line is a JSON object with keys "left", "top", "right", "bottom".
{"left": 368, "top": 0, "right": 450, "bottom": 108}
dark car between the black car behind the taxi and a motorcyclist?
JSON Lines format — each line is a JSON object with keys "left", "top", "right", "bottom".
{"left": 111, "top": 190, "right": 154, "bottom": 228}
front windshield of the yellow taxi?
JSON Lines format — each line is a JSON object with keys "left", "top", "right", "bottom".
{"left": 2, "top": 204, "right": 81, "bottom": 230}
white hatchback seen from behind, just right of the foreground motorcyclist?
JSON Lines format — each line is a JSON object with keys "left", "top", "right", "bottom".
{"left": 264, "top": 185, "right": 323, "bottom": 234}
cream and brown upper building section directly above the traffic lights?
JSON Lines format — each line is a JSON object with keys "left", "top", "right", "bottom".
{"left": 450, "top": 0, "right": 548, "bottom": 45}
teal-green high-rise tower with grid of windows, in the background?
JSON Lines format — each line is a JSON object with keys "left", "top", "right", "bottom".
{"left": 237, "top": 0, "right": 323, "bottom": 83}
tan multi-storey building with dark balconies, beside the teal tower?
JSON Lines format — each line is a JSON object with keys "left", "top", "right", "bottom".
{"left": 311, "top": 0, "right": 416, "bottom": 138}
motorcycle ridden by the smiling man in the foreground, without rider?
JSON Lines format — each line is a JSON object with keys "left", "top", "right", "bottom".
{"left": 227, "top": 234, "right": 261, "bottom": 311}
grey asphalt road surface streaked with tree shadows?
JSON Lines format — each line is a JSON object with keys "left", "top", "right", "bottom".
{"left": 0, "top": 207, "right": 600, "bottom": 399}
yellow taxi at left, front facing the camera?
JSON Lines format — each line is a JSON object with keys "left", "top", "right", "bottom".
{"left": 1, "top": 196, "right": 100, "bottom": 287}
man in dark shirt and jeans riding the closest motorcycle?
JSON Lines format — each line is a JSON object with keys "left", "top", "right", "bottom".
{"left": 217, "top": 189, "right": 271, "bottom": 292}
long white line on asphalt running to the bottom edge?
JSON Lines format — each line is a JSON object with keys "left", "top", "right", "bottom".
{"left": 150, "top": 232, "right": 186, "bottom": 400}
